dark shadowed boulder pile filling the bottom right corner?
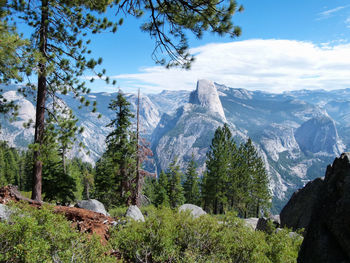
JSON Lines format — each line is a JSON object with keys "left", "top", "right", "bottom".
{"left": 281, "top": 153, "right": 350, "bottom": 263}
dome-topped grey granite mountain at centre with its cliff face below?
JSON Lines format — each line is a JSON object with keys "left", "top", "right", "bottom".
{"left": 152, "top": 80, "right": 227, "bottom": 172}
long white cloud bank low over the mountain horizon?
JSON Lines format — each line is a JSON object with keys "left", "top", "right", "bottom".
{"left": 112, "top": 39, "right": 350, "bottom": 92}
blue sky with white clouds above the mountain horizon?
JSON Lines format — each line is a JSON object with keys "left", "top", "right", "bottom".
{"left": 65, "top": 0, "right": 350, "bottom": 93}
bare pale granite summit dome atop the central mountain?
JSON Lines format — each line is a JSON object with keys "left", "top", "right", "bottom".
{"left": 189, "top": 79, "right": 226, "bottom": 121}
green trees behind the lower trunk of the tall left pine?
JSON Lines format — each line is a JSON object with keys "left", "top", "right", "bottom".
{"left": 0, "top": 140, "right": 94, "bottom": 203}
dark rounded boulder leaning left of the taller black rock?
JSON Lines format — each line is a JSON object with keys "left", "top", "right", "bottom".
{"left": 280, "top": 178, "right": 324, "bottom": 231}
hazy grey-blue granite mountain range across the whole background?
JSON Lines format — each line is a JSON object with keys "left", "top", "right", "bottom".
{"left": 0, "top": 80, "right": 350, "bottom": 212}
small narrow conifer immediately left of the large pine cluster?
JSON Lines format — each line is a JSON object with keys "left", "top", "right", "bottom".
{"left": 183, "top": 153, "right": 200, "bottom": 205}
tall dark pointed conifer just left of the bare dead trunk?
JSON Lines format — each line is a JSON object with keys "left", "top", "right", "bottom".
{"left": 95, "top": 91, "right": 137, "bottom": 207}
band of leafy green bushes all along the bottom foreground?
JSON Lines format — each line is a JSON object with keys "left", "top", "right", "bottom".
{"left": 0, "top": 204, "right": 302, "bottom": 263}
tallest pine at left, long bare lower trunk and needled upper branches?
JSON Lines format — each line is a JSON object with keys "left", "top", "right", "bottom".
{"left": 6, "top": 0, "right": 117, "bottom": 201}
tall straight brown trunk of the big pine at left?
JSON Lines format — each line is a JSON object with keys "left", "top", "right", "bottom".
{"left": 32, "top": 0, "right": 49, "bottom": 202}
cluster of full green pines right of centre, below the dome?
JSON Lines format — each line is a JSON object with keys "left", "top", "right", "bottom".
{"left": 202, "top": 124, "right": 271, "bottom": 217}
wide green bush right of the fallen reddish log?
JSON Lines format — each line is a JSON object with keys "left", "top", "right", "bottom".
{"left": 110, "top": 208, "right": 302, "bottom": 263}
